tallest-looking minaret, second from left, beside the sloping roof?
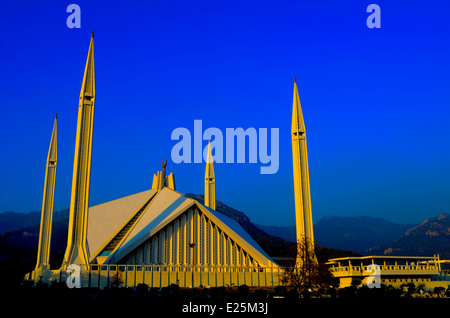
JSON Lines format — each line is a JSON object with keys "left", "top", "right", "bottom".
{"left": 63, "top": 31, "right": 95, "bottom": 266}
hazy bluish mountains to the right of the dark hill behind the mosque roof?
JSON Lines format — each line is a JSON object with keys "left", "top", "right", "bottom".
{"left": 257, "top": 213, "right": 450, "bottom": 259}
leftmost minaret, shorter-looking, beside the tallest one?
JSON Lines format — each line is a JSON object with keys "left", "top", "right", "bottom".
{"left": 36, "top": 116, "right": 57, "bottom": 270}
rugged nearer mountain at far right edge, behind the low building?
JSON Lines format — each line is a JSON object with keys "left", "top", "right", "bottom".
{"left": 368, "top": 213, "right": 450, "bottom": 259}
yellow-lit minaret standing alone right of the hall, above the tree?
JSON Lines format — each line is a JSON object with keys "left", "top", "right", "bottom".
{"left": 291, "top": 78, "right": 314, "bottom": 246}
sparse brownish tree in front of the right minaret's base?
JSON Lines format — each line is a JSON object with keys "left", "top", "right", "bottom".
{"left": 281, "top": 237, "right": 332, "bottom": 292}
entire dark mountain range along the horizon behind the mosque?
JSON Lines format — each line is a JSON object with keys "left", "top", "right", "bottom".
{"left": 0, "top": 193, "right": 450, "bottom": 272}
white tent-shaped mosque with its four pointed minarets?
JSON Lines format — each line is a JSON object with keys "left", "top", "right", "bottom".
{"left": 25, "top": 33, "right": 314, "bottom": 288}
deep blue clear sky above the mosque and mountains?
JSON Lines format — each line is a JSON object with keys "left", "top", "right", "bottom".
{"left": 0, "top": 0, "right": 450, "bottom": 225}
